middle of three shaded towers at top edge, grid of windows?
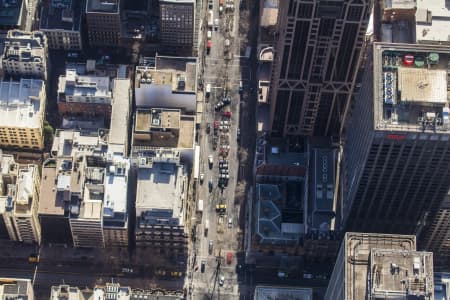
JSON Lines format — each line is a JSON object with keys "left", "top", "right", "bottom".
{"left": 86, "top": 0, "right": 120, "bottom": 47}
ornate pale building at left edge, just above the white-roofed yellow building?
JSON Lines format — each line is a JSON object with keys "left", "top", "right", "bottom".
{"left": 2, "top": 30, "right": 48, "bottom": 79}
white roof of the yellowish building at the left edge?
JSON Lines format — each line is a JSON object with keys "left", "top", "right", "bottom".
{"left": 0, "top": 79, "right": 45, "bottom": 128}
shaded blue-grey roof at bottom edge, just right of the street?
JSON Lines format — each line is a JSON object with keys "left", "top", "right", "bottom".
{"left": 253, "top": 285, "right": 313, "bottom": 300}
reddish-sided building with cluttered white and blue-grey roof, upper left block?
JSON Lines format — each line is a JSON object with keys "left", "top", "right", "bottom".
{"left": 57, "top": 69, "right": 112, "bottom": 119}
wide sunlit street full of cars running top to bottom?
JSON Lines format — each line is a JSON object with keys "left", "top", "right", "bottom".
{"left": 188, "top": 0, "right": 253, "bottom": 299}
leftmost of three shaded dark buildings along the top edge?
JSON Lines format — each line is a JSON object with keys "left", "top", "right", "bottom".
{"left": 39, "top": 0, "right": 82, "bottom": 50}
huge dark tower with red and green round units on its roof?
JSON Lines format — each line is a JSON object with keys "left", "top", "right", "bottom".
{"left": 341, "top": 42, "right": 450, "bottom": 234}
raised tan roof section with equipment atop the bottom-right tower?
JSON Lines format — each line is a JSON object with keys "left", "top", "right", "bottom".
{"left": 368, "top": 249, "right": 434, "bottom": 300}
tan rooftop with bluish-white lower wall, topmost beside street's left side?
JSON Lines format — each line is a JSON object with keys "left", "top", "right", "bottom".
{"left": 135, "top": 56, "right": 197, "bottom": 112}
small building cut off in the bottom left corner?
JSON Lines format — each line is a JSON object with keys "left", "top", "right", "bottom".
{"left": 0, "top": 277, "right": 34, "bottom": 300}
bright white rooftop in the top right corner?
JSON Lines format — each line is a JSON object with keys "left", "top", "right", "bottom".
{"left": 416, "top": 0, "right": 450, "bottom": 42}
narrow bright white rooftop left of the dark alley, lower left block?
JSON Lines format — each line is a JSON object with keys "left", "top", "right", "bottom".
{"left": 103, "top": 156, "right": 130, "bottom": 216}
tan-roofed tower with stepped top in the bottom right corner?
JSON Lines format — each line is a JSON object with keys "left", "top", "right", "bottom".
{"left": 325, "top": 232, "right": 434, "bottom": 300}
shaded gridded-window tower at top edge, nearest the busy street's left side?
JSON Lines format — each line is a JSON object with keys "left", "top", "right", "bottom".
{"left": 159, "top": 0, "right": 196, "bottom": 55}
